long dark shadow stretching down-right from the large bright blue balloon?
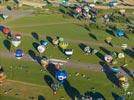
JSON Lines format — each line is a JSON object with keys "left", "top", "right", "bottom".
{"left": 63, "top": 80, "right": 81, "bottom": 100}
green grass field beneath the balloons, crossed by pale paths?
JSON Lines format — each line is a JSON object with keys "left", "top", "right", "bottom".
{"left": 0, "top": 5, "right": 134, "bottom": 100}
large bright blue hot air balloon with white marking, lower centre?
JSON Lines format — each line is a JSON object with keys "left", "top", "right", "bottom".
{"left": 55, "top": 70, "right": 68, "bottom": 84}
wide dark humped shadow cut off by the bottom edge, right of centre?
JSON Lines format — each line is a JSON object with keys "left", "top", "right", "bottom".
{"left": 85, "top": 91, "right": 106, "bottom": 100}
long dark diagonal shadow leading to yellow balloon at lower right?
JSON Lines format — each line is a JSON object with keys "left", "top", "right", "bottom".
{"left": 99, "top": 62, "right": 120, "bottom": 87}
